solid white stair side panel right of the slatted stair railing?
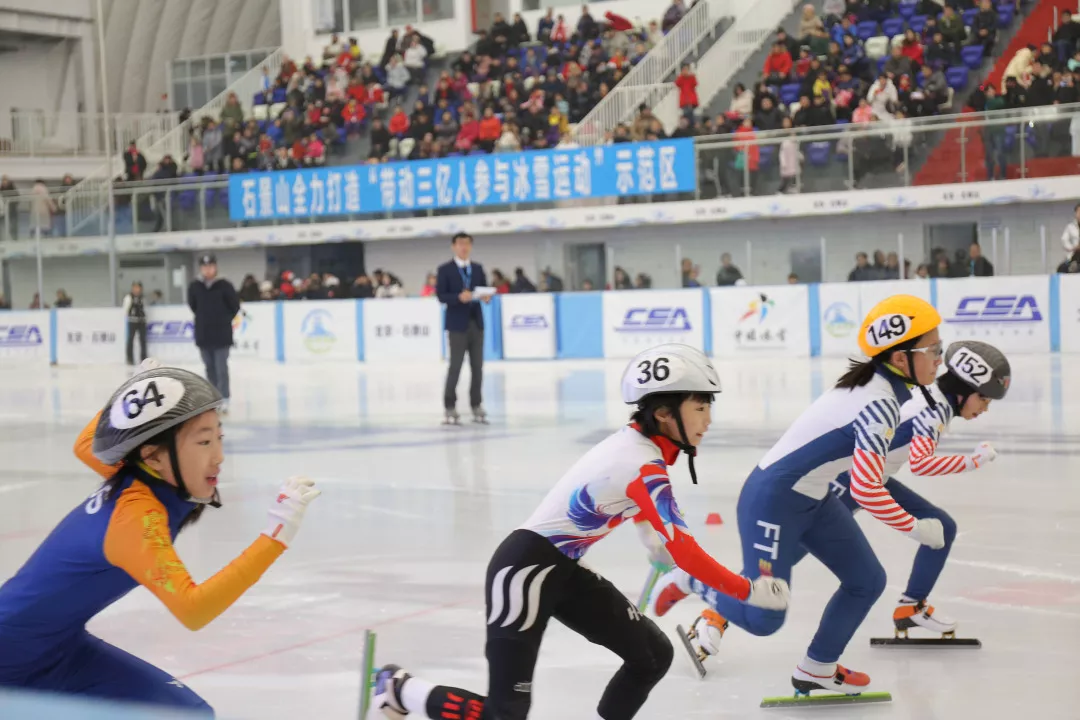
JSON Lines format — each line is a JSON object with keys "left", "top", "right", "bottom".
{"left": 698, "top": 0, "right": 797, "bottom": 108}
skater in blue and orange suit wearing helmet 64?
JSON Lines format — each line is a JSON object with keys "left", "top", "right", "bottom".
{"left": 0, "top": 367, "right": 319, "bottom": 714}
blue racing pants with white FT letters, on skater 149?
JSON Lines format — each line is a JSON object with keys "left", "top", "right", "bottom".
{"left": 691, "top": 468, "right": 886, "bottom": 663}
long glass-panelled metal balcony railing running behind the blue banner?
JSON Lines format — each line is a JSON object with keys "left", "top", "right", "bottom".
{"left": 0, "top": 102, "right": 1080, "bottom": 242}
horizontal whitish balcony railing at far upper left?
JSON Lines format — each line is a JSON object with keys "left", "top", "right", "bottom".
{"left": 0, "top": 110, "right": 178, "bottom": 158}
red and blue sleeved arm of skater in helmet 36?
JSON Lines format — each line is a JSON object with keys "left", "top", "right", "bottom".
{"left": 626, "top": 463, "right": 751, "bottom": 600}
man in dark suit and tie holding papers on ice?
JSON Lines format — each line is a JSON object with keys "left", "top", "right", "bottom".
{"left": 435, "top": 232, "right": 491, "bottom": 424}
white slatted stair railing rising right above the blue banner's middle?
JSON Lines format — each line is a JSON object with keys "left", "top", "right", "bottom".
{"left": 573, "top": 0, "right": 746, "bottom": 145}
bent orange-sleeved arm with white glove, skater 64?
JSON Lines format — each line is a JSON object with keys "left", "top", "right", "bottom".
{"left": 104, "top": 478, "right": 319, "bottom": 630}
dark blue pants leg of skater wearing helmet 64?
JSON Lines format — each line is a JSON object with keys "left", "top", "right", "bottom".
{"left": 0, "top": 633, "right": 214, "bottom": 717}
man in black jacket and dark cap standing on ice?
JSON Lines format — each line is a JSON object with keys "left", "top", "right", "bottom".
{"left": 188, "top": 254, "right": 240, "bottom": 412}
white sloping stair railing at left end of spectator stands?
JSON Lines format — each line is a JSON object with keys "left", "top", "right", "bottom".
{"left": 64, "top": 47, "right": 285, "bottom": 234}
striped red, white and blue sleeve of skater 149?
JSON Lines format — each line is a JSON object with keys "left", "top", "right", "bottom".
{"left": 851, "top": 398, "right": 915, "bottom": 532}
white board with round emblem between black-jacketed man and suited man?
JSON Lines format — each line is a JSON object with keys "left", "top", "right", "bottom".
{"left": 284, "top": 300, "right": 356, "bottom": 363}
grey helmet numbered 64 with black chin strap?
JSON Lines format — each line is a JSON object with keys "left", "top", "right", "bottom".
{"left": 93, "top": 367, "right": 224, "bottom": 507}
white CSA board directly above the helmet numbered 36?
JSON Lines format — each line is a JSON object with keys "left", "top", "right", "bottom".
{"left": 603, "top": 289, "right": 705, "bottom": 357}
